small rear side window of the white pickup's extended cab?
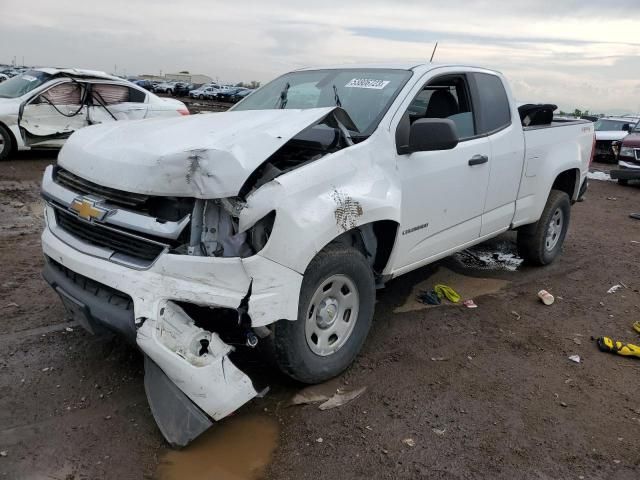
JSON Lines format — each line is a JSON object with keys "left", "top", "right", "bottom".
{"left": 473, "top": 73, "right": 511, "bottom": 134}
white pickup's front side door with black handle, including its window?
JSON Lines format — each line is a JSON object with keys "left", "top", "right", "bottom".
{"left": 396, "top": 74, "right": 491, "bottom": 271}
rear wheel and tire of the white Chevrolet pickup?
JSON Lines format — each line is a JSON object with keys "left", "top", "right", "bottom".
{"left": 518, "top": 190, "right": 571, "bottom": 265}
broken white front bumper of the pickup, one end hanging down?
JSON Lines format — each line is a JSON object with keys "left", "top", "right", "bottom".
{"left": 42, "top": 206, "right": 302, "bottom": 445}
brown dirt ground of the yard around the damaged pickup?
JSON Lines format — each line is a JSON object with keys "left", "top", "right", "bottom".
{"left": 0, "top": 153, "right": 640, "bottom": 480}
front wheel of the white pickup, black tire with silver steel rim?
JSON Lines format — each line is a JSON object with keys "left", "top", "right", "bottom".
{"left": 271, "top": 244, "right": 375, "bottom": 384}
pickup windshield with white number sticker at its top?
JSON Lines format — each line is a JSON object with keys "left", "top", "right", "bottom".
{"left": 232, "top": 69, "right": 412, "bottom": 135}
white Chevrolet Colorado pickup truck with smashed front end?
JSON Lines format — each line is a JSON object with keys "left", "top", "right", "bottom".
{"left": 42, "top": 64, "right": 594, "bottom": 445}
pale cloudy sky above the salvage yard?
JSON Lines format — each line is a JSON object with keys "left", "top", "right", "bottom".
{"left": 0, "top": 0, "right": 640, "bottom": 114}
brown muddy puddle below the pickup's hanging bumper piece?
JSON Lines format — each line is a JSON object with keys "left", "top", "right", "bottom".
{"left": 155, "top": 415, "right": 279, "bottom": 480}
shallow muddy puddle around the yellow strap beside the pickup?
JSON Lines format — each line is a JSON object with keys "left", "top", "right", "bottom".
{"left": 393, "top": 267, "right": 511, "bottom": 313}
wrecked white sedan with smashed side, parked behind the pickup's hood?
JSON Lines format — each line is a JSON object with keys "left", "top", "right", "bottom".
{"left": 0, "top": 68, "right": 189, "bottom": 160}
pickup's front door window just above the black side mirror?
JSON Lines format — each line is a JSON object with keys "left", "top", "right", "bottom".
{"left": 407, "top": 75, "right": 477, "bottom": 141}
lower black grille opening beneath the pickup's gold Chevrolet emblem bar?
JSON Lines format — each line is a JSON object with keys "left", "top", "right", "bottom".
{"left": 56, "top": 209, "right": 168, "bottom": 261}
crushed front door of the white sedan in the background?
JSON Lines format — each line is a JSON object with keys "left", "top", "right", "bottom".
{"left": 18, "top": 82, "right": 88, "bottom": 148}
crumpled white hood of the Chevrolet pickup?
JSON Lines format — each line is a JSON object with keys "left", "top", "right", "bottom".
{"left": 58, "top": 107, "right": 335, "bottom": 198}
